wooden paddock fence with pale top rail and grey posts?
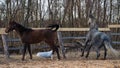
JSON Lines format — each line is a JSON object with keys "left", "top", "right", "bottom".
{"left": 0, "top": 25, "right": 120, "bottom": 58}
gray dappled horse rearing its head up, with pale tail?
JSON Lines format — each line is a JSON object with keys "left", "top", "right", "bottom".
{"left": 81, "top": 15, "right": 118, "bottom": 59}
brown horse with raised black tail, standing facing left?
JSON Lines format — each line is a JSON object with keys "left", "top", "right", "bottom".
{"left": 5, "top": 21, "right": 60, "bottom": 60}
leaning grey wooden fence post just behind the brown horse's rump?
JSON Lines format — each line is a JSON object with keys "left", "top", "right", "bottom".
{"left": 57, "top": 31, "right": 66, "bottom": 58}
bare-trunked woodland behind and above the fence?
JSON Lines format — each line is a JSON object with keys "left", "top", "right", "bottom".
{"left": 0, "top": 0, "right": 120, "bottom": 27}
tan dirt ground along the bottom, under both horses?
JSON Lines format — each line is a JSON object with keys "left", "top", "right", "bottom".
{"left": 0, "top": 52, "right": 120, "bottom": 68}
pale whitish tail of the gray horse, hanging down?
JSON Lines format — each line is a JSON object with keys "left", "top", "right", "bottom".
{"left": 104, "top": 41, "right": 119, "bottom": 57}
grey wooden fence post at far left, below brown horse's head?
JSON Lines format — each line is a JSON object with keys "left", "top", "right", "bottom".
{"left": 1, "top": 34, "right": 9, "bottom": 59}
